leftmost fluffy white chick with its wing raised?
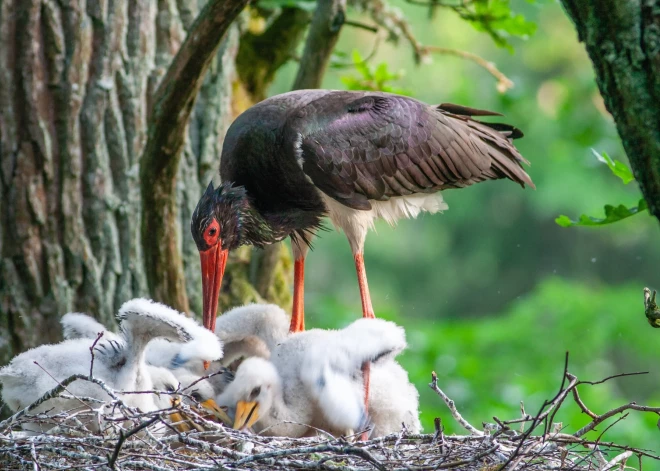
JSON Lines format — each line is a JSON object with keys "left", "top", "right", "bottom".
{"left": 0, "top": 299, "right": 222, "bottom": 432}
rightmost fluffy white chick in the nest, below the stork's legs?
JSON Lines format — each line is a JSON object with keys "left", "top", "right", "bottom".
{"left": 217, "top": 319, "right": 419, "bottom": 437}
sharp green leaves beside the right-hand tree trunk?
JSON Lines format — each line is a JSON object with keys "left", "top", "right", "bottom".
{"left": 555, "top": 149, "right": 648, "bottom": 227}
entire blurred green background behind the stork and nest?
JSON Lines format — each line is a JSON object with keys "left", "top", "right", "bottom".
{"left": 270, "top": 0, "right": 660, "bottom": 460}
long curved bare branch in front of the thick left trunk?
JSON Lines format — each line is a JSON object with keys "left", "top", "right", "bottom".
{"left": 140, "top": 0, "right": 248, "bottom": 311}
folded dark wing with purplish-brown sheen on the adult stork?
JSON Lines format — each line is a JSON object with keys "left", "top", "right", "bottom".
{"left": 288, "top": 92, "right": 534, "bottom": 209}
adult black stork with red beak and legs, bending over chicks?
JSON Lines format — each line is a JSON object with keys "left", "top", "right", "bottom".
{"left": 191, "top": 90, "right": 533, "bottom": 412}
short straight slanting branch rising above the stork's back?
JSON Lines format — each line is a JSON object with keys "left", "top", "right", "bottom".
{"left": 292, "top": 0, "right": 346, "bottom": 90}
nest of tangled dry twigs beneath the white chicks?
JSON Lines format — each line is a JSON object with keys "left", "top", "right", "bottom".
{"left": 0, "top": 356, "right": 660, "bottom": 471}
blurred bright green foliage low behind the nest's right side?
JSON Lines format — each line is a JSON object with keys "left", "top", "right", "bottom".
{"left": 311, "top": 278, "right": 660, "bottom": 469}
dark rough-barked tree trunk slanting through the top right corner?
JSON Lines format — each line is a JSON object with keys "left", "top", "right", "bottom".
{"left": 562, "top": 0, "right": 660, "bottom": 225}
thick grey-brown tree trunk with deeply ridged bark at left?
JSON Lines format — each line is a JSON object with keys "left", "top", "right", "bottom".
{"left": 0, "top": 0, "right": 302, "bottom": 364}
